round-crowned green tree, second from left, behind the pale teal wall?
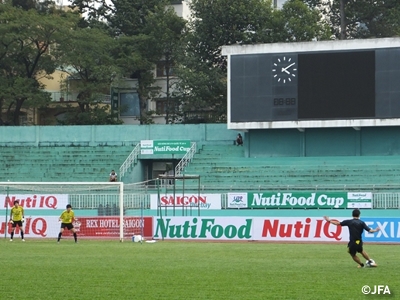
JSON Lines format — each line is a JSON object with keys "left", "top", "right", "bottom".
{"left": 58, "top": 26, "right": 120, "bottom": 125}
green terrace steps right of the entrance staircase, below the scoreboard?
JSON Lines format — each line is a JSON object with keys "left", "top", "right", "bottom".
{"left": 185, "top": 145, "right": 400, "bottom": 189}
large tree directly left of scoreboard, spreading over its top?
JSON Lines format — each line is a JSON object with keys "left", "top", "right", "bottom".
{"left": 173, "top": 0, "right": 329, "bottom": 122}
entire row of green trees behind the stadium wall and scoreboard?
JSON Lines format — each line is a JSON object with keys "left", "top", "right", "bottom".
{"left": 0, "top": 0, "right": 400, "bottom": 125}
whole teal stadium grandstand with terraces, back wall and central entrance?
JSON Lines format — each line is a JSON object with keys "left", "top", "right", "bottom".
{"left": 0, "top": 124, "right": 400, "bottom": 192}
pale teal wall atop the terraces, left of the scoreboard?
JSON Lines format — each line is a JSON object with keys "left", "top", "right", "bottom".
{"left": 0, "top": 124, "right": 237, "bottom": 146}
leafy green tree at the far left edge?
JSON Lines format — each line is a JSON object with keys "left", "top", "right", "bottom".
{"left": 0, "top": 4, "right": 77, "bottom": 125}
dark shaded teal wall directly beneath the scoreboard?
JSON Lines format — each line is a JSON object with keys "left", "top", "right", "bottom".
{"left": 244, "top": 126, "right": 400, "bottom": 157}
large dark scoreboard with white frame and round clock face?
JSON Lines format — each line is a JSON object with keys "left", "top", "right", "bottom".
{"left": 222, "top": 38, "right": 400, "bottom": 129}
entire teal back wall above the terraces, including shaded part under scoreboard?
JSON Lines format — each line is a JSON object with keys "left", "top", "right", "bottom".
{"left": 0, "top": 124, "right": 400, "bottom": 157}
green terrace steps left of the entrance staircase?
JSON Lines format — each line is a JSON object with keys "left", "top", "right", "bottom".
{"left": 0, "top": 146, "right": 134, "bottom": 182}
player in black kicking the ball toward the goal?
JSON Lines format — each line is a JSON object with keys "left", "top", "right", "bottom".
{"left": 324, "top": 209, "right": 380, "bottom": 268}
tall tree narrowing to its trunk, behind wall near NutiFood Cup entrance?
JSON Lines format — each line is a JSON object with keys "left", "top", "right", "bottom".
{"left": 73, "top": 0, "right": 186, "bottom": 124}
